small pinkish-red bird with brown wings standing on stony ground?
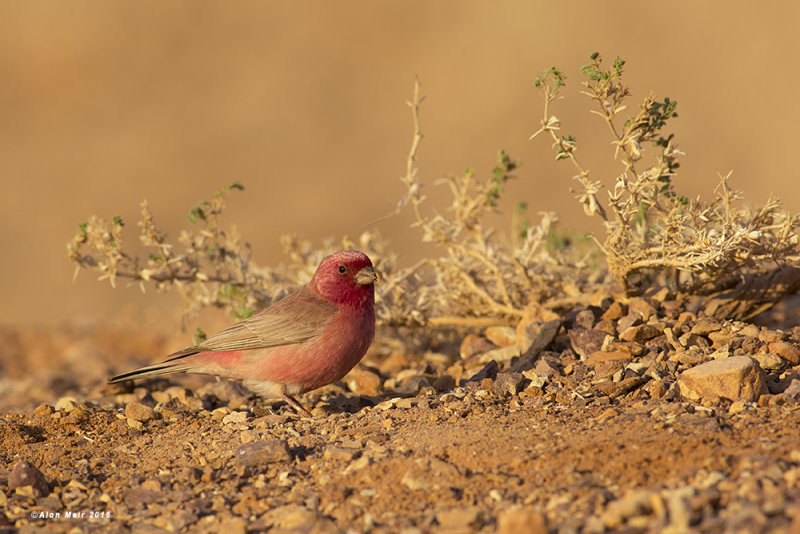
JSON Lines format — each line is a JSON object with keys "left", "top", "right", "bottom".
{"left": 109, "top": 250, "right": 377, "bottom": 416}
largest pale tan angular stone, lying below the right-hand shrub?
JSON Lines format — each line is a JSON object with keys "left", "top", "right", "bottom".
{"left": 678, "top": 356, "right": 767, "bottom": 401}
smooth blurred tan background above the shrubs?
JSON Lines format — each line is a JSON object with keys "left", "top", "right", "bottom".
{"left": 0, "top": 0, "right": 800, "bottom": 324}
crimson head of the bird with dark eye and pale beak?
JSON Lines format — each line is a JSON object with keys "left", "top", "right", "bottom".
{"left": 310, "top": 250, "right": 378, "bottom": 306}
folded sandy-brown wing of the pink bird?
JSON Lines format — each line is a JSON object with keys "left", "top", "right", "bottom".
{"left": 187, "top": 288, "right": 338, "bottom": 357}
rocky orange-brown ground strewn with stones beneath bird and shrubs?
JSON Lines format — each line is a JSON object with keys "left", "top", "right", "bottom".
{"left": 0, "top": 294, "right": 800, "bottom": 534}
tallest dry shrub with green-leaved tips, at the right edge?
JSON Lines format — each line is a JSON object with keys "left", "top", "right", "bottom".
{"left": 531, "top": 53, "right": 800, "bottom": 319}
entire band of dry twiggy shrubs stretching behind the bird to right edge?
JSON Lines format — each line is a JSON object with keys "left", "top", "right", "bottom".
{"left": 68, "top": 54, "right": 800, "bottom": 327}
